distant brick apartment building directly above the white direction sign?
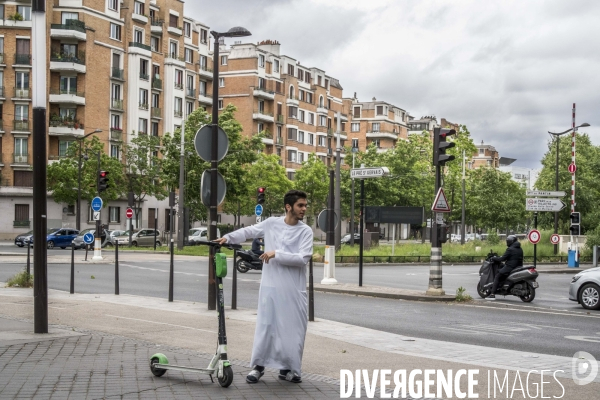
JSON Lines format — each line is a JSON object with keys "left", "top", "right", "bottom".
{"left": 349, "top": 94, "right": 409, "bottom": 151}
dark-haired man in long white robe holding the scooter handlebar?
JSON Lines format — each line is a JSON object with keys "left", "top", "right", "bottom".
{"left": 217, "top": 190, "right": 313, "bottom": 383}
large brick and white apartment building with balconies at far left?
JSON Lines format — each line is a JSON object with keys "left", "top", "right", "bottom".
{"left": 0, "top": 0, "right": 212, "bottom": 238}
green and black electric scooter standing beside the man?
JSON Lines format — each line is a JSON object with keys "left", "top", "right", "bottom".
{"left": 150, "top": 242, "right": 242, "bottom": 387}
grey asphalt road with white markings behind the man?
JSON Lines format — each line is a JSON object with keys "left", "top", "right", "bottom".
{"left": 0, "top": 260, "right": 600, "bottom": 358}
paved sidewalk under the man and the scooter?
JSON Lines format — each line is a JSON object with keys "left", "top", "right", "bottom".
{"left": 0, "top": 285, "right": 600, "bottom": 399}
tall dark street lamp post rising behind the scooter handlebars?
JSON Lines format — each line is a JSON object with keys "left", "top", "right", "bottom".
{"left": 209, "top": 26, "right": 251, "bottom": 310}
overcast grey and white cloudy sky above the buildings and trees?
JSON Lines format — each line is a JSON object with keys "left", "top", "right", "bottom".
{"left": 185, "top": 0, "right": 600, "bottom": 168}
